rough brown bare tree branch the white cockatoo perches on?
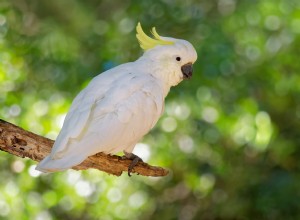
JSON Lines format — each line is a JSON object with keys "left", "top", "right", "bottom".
{"left": 0, "top": 119, "right": 168, "bottom": 176}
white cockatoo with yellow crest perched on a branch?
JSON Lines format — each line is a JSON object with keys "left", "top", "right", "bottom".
{"left": 36, "top": 23, "right": 197, "bottom": 175}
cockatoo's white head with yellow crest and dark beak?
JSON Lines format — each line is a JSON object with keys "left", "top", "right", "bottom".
{"left": 136, "top": 23, "right": 197, "bottom": 86}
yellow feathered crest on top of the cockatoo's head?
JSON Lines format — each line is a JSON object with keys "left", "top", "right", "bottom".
{"left": 136, "top": 22, "right": 174, "bottom": 50}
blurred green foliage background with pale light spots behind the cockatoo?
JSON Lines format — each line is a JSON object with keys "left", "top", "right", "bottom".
{"left": 0, "top": 0, "right": 300, "bottom": 220}
